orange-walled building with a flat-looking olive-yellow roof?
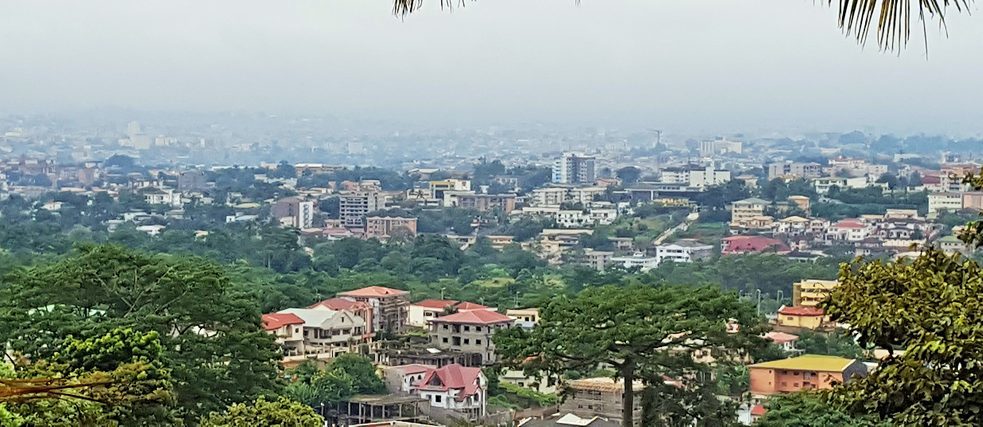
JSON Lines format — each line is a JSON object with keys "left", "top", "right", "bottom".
{"left": 748, "top": 354, "right": 867, "bottom": 396}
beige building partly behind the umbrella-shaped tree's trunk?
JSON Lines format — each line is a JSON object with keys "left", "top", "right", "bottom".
{"left": 560, "top": 377, "right": 645, "bottom": 425}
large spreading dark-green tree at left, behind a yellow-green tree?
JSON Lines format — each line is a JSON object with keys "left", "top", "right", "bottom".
{"left": 0, "top": 245, "right": 279, "bottom": 420}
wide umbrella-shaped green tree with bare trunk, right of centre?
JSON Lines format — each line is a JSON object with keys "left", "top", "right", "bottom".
{"left": 495, "top": 286, "right": 764, "bottom": 426}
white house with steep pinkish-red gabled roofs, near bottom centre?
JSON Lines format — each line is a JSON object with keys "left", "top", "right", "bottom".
{"left": 411, "top": 364, "right": 488, "bottom": 420}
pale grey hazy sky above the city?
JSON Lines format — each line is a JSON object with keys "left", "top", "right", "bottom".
{"left": 0, "top": 0, "right": 983, "bottom": 135}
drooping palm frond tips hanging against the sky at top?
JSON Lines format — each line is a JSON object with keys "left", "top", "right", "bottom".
{"left": 393, "top": 0, "right": 972, "bottom": 50}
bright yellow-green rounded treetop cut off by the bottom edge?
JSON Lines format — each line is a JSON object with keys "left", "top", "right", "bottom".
{"left": 201, "top": 397, "right": 324, "bottom": 427}
